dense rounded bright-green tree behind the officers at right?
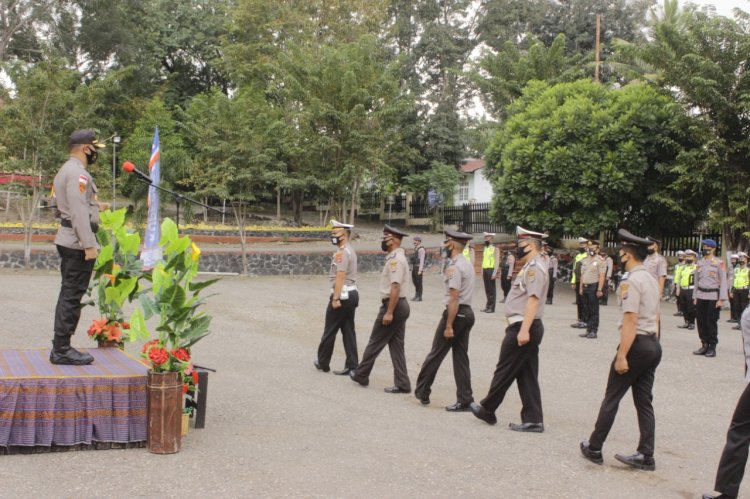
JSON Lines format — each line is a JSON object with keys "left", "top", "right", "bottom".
{"left": 487, "top": 80, "right": 702, "bottom": 236}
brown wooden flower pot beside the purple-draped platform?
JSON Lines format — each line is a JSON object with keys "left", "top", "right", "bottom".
{"left": 147, "top": 371, "right": 182, "bottom": 454}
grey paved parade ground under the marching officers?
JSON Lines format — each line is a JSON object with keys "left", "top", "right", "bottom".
{"left": 0, "top": 271, "right": 750, "bottom": 499}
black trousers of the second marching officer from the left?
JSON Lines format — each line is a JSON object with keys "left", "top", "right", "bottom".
{"left": 355, "top": 298, "right": 411, "bottom": 390}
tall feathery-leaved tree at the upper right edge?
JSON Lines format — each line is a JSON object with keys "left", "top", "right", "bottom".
{"left": 618, "top": 0, "right": 750, "bottom": 249}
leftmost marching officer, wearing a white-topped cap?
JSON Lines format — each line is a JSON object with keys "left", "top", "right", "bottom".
{"left": 314, "top": 220, "right": 359, "bottom": 375}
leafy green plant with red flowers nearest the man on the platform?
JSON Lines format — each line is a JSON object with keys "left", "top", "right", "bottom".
{"left": 88, "top": 208, "right": 149, "bottom": 348}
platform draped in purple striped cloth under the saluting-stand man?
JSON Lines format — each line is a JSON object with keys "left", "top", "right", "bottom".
{"left": 0, "top": 348, "right": 148, "bottom": 454}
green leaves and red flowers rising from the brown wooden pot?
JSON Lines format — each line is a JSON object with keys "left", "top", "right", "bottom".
{"left": 130, "top": 218, "right": 218, "bottom": 382}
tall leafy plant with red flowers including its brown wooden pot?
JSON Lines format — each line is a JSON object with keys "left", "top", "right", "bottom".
{"left": 130, "top": 218, "right": 218, "bottom": 454}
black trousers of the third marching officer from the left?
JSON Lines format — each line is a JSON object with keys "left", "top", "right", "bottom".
{"left": 415, "top": 305, "right": 474, "bottom": 404}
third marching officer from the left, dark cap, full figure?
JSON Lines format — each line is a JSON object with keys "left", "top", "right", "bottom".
{"left": 414, "top": 230, "right": 474, "bottom": 412}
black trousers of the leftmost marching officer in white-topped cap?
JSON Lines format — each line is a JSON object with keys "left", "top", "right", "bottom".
{"left": 318, "top": 291, "right": 359, "bottom": 369}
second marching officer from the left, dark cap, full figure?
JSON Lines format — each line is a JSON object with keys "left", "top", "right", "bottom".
{"left": 349, "top": 225, "right": 411, "bottom": 393}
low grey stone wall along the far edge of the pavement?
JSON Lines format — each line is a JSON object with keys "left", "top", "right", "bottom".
{"left": 0, "top": 248, "right": 439, "bottom": 275}
